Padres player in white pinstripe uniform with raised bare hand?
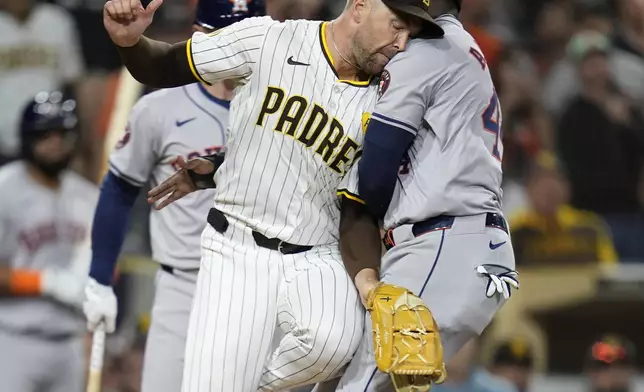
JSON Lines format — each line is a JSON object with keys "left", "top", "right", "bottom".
{"left": 92, "top": 0, "right": 443, "bottom": 392}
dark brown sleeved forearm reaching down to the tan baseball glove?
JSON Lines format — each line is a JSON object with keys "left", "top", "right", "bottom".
{"left": 340, "top": 198, "right": 381, "bottom": 283}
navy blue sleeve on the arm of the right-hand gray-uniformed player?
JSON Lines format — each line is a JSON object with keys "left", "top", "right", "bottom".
{"left": 358, "top": 116, "right": 415, "bottom": 219}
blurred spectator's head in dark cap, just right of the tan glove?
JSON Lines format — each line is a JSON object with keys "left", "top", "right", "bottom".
{"left": 488, "top": 339, "right": 534, "bottom": 392}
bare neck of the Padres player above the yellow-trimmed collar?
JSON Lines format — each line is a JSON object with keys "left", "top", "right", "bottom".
{"left": 324, "top": 15, "right": 369, "bottom": 80}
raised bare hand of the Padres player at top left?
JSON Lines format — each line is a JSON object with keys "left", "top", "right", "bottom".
{"left": 103, "top": 0, "right": 163, "bottom": 48}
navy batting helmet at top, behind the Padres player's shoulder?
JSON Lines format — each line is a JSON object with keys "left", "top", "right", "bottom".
{"left": 195, "top": 0, "right": 266, "bottom": 30}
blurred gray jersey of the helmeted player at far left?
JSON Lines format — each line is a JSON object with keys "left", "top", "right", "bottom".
{"left": 0, "top": 161, "right": 98, "bottom": 337}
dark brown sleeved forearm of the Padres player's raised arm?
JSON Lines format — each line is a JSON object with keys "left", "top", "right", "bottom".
{"left": 117, "top": 37, "right": 197, "bottom": 88}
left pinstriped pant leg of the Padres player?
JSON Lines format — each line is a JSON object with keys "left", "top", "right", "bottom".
{"left": 182, "top": 226, "right": 281, "bottom": 392}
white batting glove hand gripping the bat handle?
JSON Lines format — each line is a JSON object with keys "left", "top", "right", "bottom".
{"left": 83, "top": 278, "right": 117, "bottom": 333}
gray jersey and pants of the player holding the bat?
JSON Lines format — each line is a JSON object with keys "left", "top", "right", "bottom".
{"left": 110, "top": 83, "right": 229, "bottom": 392}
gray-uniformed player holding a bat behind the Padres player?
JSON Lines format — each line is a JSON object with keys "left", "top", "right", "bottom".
{"left": 84, "top": 0, "right": 265, "bottom": 392}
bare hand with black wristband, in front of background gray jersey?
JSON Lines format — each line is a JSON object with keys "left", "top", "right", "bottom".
{"left": 148, "top": 156, "right": 215, "bottom": 210}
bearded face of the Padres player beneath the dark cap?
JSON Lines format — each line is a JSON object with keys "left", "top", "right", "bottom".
{"left": 353, "top": 3, "right": 420, "bottom": 75}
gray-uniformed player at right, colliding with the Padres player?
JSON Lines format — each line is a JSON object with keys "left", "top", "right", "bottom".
{"left": 330, "top": 0, "right": 518, "bottom": 392}
